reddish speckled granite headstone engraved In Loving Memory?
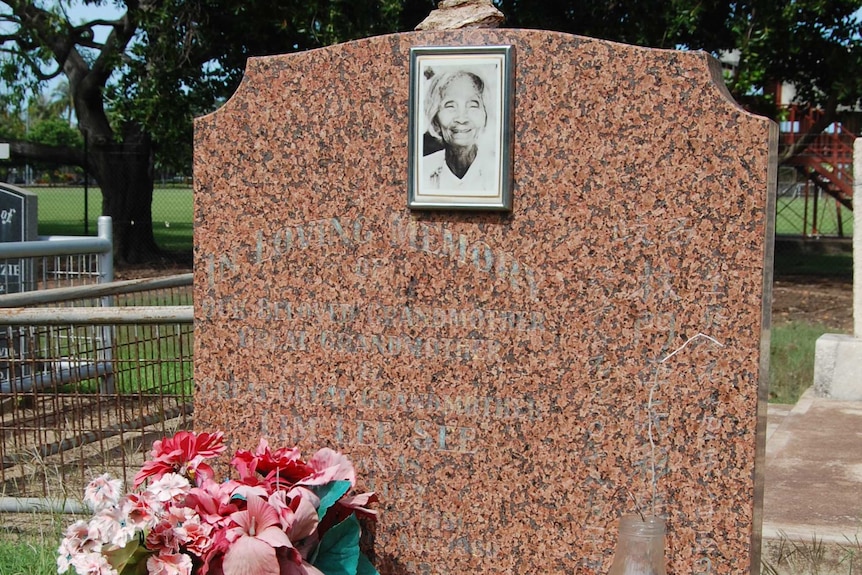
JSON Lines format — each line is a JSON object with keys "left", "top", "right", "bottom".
{"left": 195, "top": 30, "right": 777, "bottom": 575}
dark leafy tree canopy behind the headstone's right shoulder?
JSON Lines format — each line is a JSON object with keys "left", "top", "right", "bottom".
{"left": 497, "top": 0, "right": 862, "bottom": 156}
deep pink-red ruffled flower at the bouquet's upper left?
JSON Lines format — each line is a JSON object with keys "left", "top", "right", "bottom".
{"left": 134, "top": 431, "right": 225, "bottom": 488}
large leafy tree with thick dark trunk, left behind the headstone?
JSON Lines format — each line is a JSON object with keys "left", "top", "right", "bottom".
{"left": 0, "top": 0, "right": 400, "bottom": 262}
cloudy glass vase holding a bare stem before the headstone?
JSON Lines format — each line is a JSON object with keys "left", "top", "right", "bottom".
{"left": 608, "top": 515, "right": 667, "bottom": 575}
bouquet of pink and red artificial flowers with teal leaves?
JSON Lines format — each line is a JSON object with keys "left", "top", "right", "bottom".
{"left": 57, "top": 431, "right": 377, "bottom": 575}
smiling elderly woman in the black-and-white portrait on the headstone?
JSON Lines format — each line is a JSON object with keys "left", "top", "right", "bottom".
{"left": 422, "top": 70, "right": 494, "bottom": 191}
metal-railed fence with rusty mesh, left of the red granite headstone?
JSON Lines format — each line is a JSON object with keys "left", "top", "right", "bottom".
{"left": 0, "top": 223, "right": 193, "bottom": 511}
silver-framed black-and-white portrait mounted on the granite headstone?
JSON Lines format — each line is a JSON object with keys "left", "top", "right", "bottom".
{"left": 407, "top": 46, "right": 514, "bottom": 211}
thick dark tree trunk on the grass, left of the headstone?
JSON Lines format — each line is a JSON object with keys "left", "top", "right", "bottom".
{"left": 88, "top": 128, "right": 163, "bottom": 264}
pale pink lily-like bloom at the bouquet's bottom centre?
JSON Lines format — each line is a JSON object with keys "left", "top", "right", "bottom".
{"left": 223, "top": 497, "right": 292, "bottom": 575}
